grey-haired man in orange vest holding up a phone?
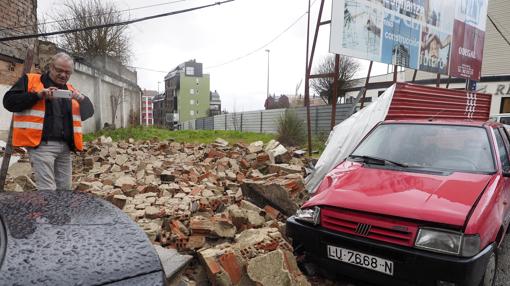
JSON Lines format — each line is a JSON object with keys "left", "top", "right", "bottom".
{"left": 3, "top": 53, "right": 94, "bottom": 190}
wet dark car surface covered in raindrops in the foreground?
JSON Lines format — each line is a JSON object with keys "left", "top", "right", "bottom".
{"left": 0, "top": 191, "right": 162, "bottom": 285}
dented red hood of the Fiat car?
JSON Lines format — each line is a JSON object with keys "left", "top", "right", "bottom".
{"left": 304, "top": 161, "right": 492, "bottom": 227}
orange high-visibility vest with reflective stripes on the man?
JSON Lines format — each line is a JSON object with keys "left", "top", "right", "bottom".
{"left": 12, "top": 73, "right": 83, "bottom": 151}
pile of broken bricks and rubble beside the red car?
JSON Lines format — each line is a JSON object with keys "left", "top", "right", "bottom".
{"left": 73, "top": 137, "right": 309, "bottom": 285}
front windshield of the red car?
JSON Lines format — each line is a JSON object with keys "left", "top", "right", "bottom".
{"left": 351, "top": 123, "right": 495, "bottom": 173}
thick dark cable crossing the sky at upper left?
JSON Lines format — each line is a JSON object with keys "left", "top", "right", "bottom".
{"left": 0, "top": 0, "right": 235, "bottom": 42}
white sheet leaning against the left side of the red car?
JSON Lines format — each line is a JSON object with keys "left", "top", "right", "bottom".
{"left": 306, "top": 85, "right": 396, "bottom": 193}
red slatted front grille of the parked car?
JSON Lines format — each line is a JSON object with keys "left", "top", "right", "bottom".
{"left": 321, "top": 208, "right": 418, "bottom": 246}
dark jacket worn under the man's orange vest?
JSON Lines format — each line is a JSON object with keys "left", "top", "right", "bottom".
{"left": 3, "top": 73, "right": 94, "bottom": 150}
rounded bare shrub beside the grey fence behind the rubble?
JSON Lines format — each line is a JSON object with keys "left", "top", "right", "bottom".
{"left": 278, "top": 110, "right": 306, "bottom": 146}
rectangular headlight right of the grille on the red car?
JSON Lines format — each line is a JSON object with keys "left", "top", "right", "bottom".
{"left": 414, "top": 228, "right": 480, "bottom": 257}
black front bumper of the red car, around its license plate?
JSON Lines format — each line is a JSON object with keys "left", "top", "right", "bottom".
{"left": 287, "top": 217, "right": 494, "bottom": 286}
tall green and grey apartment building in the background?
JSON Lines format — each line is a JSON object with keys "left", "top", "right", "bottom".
{"left": 163, "top": 60, "right": 211, "bottom": 125}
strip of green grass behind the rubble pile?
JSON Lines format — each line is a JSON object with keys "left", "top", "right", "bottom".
{"left": 84, "top": 127, "right": 275, "bottom": 144}
